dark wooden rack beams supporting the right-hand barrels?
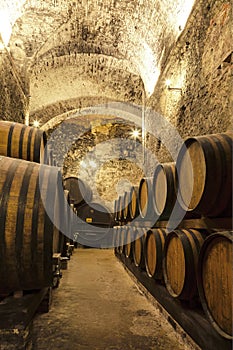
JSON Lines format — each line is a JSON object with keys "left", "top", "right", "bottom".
{"left": 115, "top": 217, "right": 232, "bottom": 350}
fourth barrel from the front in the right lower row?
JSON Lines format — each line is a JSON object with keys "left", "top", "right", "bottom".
{"left": 132, "top": 228, "right": 146, "bottom": 269}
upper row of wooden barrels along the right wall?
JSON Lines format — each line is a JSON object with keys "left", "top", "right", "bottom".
{"left": 115, "top": 132, "right": 233, "bottom": 222}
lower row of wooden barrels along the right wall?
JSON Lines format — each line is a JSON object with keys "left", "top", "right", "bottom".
{"left": 114, "top": 226, "right": 233, "bottom": 339}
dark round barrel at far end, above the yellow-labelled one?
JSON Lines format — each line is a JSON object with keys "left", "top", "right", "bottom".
{"left": 63, "top": 176, "right": 92, "bottom": 206}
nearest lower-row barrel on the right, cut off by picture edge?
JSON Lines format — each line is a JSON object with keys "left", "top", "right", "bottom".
{"left": 198, "top": 232, "right": 233, "bottom": 339}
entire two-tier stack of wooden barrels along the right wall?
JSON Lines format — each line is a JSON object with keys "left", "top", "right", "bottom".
{"left": 115, "top": 133, "right": 233, "bottom": 339}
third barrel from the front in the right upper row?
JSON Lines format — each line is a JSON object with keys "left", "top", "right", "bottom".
{"left": 138, "top": 177, "right": 155, "bottom": 220}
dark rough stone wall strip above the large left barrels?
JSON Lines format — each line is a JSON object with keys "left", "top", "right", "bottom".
{"left": 0, "top": 39, "right": 28, "bottom": 123}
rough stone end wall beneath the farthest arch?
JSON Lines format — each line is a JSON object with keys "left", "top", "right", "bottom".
{"left": 47, "top": 116, "right": 144, "bottom": 208}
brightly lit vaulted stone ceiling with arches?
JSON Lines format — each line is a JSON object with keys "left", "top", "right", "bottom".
{"left": 0, "top": 0, "right": 194, "bottom": 121}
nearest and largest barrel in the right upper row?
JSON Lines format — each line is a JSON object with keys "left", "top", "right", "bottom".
{"left": 177, "top": 133, "right": 232, "bottom": 217}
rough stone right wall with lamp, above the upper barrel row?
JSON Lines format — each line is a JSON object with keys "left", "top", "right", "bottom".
{"left": 146, "top": 0, "right": 233, "bottom": 168}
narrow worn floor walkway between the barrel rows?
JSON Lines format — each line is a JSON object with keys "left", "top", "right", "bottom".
{"left": 33, "top": 249, "right": 190, "bottom": 350}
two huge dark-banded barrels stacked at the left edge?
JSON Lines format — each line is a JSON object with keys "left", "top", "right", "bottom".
{"left": 0, "top": 121, "right": 71, "bottom": 295}
